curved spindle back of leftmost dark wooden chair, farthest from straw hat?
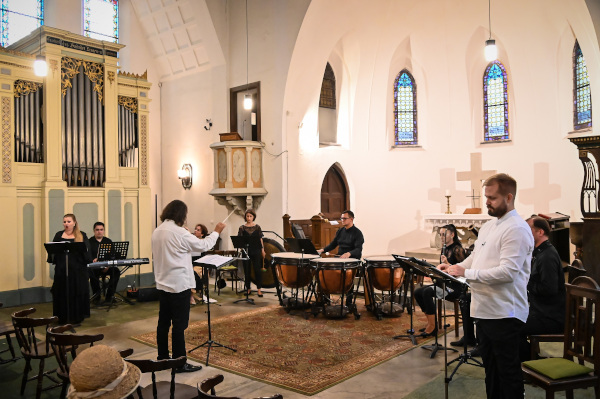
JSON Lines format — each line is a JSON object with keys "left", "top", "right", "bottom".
{"left": 11, "top": 308, "right": 58, "bottom": 357}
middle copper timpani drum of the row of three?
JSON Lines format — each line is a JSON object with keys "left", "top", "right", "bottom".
{"left": 310, "top": 258, "right": 362, "bottom": 319}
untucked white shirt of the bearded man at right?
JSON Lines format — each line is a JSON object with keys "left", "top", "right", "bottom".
{"left": 459, "top": 209, "right": 534, "bottom": 322}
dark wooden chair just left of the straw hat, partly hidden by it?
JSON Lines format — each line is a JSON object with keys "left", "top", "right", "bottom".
{"left": 47, "top": 324, "right": 104, "bottom": 398}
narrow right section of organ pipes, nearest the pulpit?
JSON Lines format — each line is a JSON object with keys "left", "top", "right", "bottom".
{"left": 119, "top": 96, "right": 138, "bottom": 168}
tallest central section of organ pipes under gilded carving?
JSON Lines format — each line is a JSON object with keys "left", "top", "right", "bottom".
{"left": 61, "top": 57, "right": 104, "bottom": 187}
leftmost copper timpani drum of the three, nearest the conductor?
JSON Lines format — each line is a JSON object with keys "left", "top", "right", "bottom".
{"left": 271, "top": 252, "right": 319, "bottom": 312}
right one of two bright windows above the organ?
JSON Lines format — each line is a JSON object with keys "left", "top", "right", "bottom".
{"left": 84, "top": 0, "right": 119, "bottom": 43}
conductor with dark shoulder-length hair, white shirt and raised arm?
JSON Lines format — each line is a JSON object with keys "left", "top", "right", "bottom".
{"left": 152, "top": 200, "right": 225, "bottom": 373}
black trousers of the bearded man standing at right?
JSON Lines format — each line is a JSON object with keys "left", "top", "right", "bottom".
{"left": 476, "top": 318, "right": 525, "bottom": 399}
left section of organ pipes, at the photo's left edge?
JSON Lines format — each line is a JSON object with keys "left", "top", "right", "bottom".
{"left": 14, "top": 80, "right": 44, "bottom": 163}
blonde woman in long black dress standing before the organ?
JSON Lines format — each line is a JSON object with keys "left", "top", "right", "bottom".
{"left": 48, "top": 213, "right": 92, "bottom": 324}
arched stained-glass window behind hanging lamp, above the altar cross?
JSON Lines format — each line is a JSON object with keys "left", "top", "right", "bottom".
{"left": 483, "top": 61, "right": 509, "bottom": 141}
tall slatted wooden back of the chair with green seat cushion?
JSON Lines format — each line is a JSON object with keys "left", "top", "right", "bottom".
{"left": 563, "top": 276, "right": 600, "bottom": 375}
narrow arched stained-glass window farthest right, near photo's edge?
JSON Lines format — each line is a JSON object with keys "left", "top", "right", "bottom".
{"left": 573, "top": 40, "right": 592, "bottom": 130}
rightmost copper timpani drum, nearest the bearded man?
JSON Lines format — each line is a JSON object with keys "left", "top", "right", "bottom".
{"left": 365, "top": 255, "right": 404, "bottom": 320}
